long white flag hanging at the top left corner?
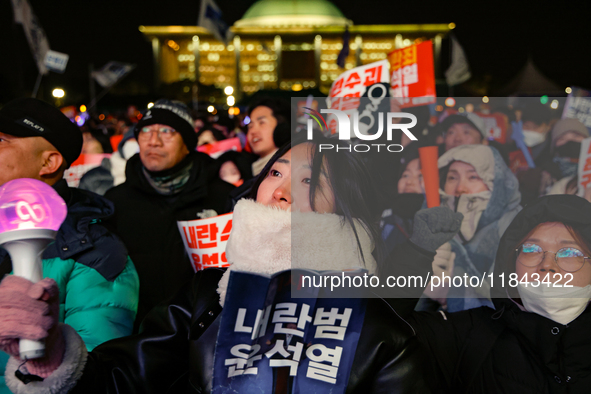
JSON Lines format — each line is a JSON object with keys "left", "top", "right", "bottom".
{"left": 12, "top": 0, "right": 49, "bottom": 74}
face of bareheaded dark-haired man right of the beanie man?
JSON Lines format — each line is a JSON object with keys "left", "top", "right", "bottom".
{"left": 246, "top": 106, "right": 277, "bottom": 157}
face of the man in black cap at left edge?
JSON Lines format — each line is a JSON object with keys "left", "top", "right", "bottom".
{"left": 0, "top": 132, "right": 45, "bottom": 186}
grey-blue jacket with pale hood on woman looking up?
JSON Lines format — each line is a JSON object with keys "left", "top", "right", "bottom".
{"left": 438, "top": 145, "right": 521, "bottom": 312}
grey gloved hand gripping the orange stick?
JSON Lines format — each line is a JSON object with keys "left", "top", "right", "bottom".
{"left": 410, "top": 207, "right": 464, "bottom": 252}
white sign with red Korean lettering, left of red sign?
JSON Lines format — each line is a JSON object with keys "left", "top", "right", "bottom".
{"left": 326, "top": 60, "right": 390, "bottom": 134}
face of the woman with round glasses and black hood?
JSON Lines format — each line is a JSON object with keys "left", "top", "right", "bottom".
{"left": 515, "top": 222, "right": 591, "bottom": 287}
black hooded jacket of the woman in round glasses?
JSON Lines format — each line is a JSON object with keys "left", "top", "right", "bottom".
{"left": 410, "top": 195, "right": 591, "bottom": 394}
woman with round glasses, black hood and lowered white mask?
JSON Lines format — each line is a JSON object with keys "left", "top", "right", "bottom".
{"left": 410, "top": 195, "right": 591, "bottom": 394}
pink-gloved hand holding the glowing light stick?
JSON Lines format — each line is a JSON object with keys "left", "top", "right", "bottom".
{"left": 0, "top": 275, "right": 65, "bottom": 378}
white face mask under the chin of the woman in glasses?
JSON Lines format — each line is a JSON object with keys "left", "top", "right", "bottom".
{"left": 517, "top": 283, "right": 591, "bottom": 325}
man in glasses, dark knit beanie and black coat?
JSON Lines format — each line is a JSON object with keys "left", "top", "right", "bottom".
{"left": 105, "top": 99, "right": 234, "bottom": 331}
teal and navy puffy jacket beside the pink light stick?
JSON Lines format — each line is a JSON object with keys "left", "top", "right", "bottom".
{"left": 0, "top": 181, "right": 139, "bottom": 392}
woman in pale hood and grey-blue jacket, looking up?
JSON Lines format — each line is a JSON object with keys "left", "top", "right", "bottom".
{"left": 438, "top": 145, "right": 521, "bottom": 312}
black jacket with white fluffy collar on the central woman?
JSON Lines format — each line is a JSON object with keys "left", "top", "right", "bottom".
{"left": 10, "top": 200, "right": 438, "bottom": 394}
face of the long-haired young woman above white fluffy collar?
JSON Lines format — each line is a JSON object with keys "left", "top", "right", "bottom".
{"left": 257, "top": 144, "right": 335, "bottom": 213}
